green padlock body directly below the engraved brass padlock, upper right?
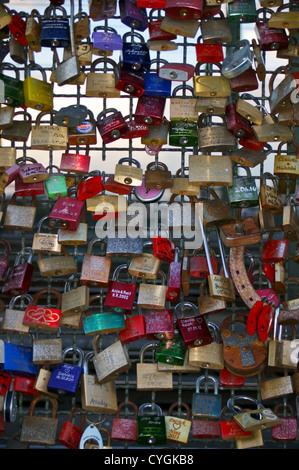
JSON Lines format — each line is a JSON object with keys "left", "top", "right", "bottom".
{"left": 169, "top": 120, "right": 198, "bottom": 147}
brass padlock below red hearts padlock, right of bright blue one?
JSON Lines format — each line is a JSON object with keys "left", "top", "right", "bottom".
{"left": 32, "top": 329, "right": 62, "bottom": 365}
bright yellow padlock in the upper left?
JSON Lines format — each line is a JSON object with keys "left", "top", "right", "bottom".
{"left": 24, "top": 63, "right": 53, "bottom": 112}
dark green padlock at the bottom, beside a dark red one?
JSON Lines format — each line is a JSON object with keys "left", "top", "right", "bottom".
{"left": 137, "top": 403, "right": 166, "bottom": 445}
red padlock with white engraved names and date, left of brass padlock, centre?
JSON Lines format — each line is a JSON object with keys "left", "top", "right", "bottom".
{"left": 104, "top": 264, "right": 137, "bottom": 315}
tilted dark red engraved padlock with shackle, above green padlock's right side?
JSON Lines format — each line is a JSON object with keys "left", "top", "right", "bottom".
{"left": 175, "top": 302, "right": 213, "bottom": 348}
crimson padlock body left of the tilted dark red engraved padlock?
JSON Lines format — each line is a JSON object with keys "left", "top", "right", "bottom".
{"left": 144, "top": 309, "right": 175, "bottom": 340}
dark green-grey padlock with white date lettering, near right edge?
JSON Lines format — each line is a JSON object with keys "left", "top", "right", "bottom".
{"left": 227, "top": 165, "right": 259, "bottom": 207}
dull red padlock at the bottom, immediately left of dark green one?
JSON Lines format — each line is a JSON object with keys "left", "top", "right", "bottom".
{"left": 111, "top": 401, "right": 138, "bottom": 442}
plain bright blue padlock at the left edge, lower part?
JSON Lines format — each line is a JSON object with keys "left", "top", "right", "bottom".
{"left": 2, "top": 343, "right": 39, "bottom": 377}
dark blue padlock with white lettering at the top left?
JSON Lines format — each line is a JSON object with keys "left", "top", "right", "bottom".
{"left": 40, "top": 5, "right": 71, "bottom": 48}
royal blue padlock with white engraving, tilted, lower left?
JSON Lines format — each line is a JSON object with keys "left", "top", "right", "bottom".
{"left": 47, "top": 346, "right": 84, "bottom": 395}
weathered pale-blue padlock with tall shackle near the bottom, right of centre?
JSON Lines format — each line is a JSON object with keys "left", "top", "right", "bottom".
{"left": 191, "top": 375, "right": 221, "bottom": 420}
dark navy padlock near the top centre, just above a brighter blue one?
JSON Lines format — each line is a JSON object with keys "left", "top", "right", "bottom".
{"left": 121, "top": 32, "right": 151, "bottom": 72}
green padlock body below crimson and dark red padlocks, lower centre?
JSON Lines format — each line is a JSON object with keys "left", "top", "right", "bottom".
{"left": 155, "top": 333, "right": 186, "bottom": 366}
